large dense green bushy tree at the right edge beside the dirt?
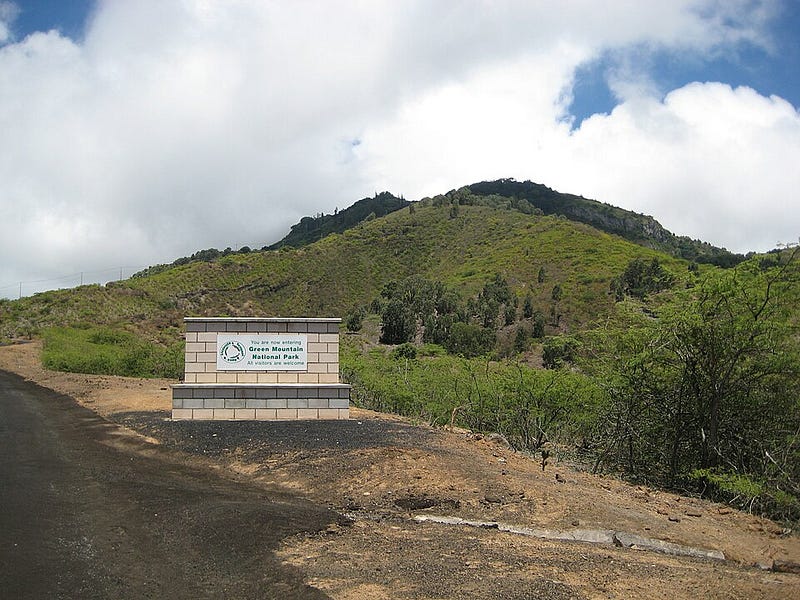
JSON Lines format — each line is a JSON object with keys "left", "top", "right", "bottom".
{"left": 587, "top": 250, "right": 800, "bottom": 518}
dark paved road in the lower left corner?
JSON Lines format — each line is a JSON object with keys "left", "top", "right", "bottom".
{"left": 0, "top": 371, "right": 336, "bottom": 599}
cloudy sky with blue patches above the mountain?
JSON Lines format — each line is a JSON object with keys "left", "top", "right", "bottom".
{"left": 0, "top": 0, "right": 800, "bottom": 298}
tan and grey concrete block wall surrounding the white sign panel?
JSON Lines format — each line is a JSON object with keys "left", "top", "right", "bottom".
{"left": 172, "top": 317, "right": 350, "bottom": 420}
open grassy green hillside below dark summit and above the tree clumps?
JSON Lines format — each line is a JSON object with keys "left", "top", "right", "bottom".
{"left": 0, "top": 201, "right": 687, "bottom": 338}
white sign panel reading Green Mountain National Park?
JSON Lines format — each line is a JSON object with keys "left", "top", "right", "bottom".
{"left": 217, "top": 333, "right": 308, "bottom": 371}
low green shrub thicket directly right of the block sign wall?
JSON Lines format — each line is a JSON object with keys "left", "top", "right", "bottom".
{"left": 341, "top": 344, "right": 603, "bottom": 450}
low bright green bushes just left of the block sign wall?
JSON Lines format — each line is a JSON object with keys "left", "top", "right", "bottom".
{"left": 42, "top": 327, "right": 183, "bottom": 379}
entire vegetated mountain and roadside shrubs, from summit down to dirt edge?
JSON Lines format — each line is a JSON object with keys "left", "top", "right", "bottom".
{"left": 0, "top": 180, "right": 800, "bottom": 521}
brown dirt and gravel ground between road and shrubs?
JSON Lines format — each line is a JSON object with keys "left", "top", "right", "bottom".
{"left": 0, "top": 342, "right": 800, "bottom": 599}
